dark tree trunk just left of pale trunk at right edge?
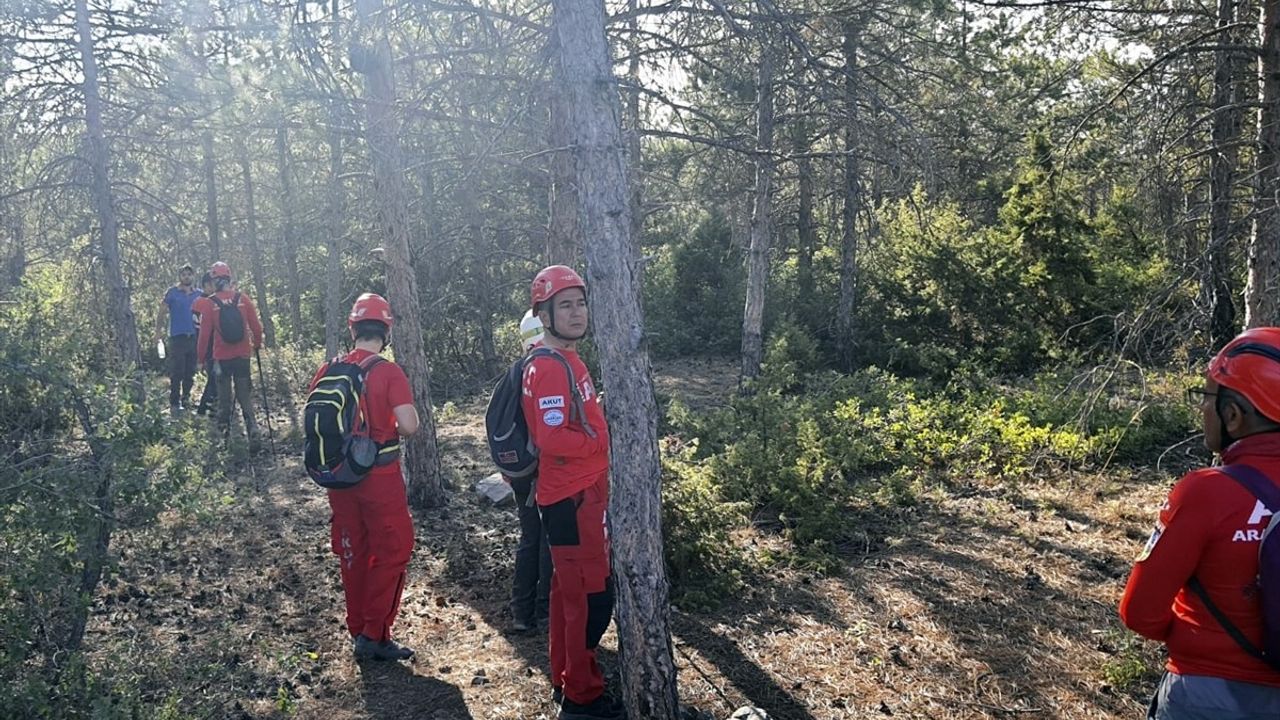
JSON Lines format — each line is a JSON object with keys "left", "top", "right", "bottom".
{"left": 1201, "top": 0, "right": 1244, "bottom": 347}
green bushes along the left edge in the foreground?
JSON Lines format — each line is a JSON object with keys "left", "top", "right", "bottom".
{"left": 0, "top": 273, "right": 225, "bottom": 719}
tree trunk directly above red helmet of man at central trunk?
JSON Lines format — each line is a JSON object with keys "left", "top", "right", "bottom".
{"left": 547, "top": 51, "right": 582, "bottom": 265}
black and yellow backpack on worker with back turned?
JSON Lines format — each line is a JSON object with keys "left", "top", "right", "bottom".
{"left": 302, "top": 355, "right": 399, "bottom": 489}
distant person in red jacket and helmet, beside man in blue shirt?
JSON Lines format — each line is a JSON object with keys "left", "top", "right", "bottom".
{"left": 196, "top": 261, "right": 262, "bottom": 452}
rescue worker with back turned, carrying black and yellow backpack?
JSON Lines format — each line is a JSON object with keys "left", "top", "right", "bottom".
{"left": 311, "top": 292, "right": 419, "bottom": 660}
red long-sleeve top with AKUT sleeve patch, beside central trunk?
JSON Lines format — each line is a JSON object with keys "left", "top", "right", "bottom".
{"left": 521, "top": 350, "right": 609, "bottom": 505}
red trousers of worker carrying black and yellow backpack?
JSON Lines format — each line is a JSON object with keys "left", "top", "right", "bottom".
{"left": 329, "top": 464, "right": 413, "bottom": 641}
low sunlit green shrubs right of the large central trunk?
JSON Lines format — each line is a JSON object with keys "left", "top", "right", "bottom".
{"left": 664, "top": 327, "right": 1193, "bottom": 600}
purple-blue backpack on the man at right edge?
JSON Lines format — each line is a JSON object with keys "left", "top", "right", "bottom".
{"left": 1187, "top": 465, "right": 1280, "bottom": 670}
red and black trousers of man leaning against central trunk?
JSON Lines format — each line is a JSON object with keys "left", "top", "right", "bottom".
{"left": 539, "top": 474, "right": 613, "bottom": 705}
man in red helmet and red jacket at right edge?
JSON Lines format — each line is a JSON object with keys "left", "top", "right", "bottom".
{"left": 1120, "top": 328, "right": 1280, "bottom": 720}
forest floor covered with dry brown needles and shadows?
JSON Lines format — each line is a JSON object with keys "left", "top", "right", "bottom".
{"left": 86, "top": 361, "right": 1169, "bottom": 720}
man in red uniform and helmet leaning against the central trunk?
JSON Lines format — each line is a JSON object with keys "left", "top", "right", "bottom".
{"left": 521, "top": 265, "right": 622, "bottom": 720}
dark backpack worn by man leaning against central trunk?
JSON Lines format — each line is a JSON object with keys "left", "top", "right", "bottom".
{"left": 484, "top": 347, "right": 595, "bottom": 479}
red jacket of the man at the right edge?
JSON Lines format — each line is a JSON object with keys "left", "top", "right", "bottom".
{"left": 1120, "top": 433, "right": 1280, "bottom": 687}
